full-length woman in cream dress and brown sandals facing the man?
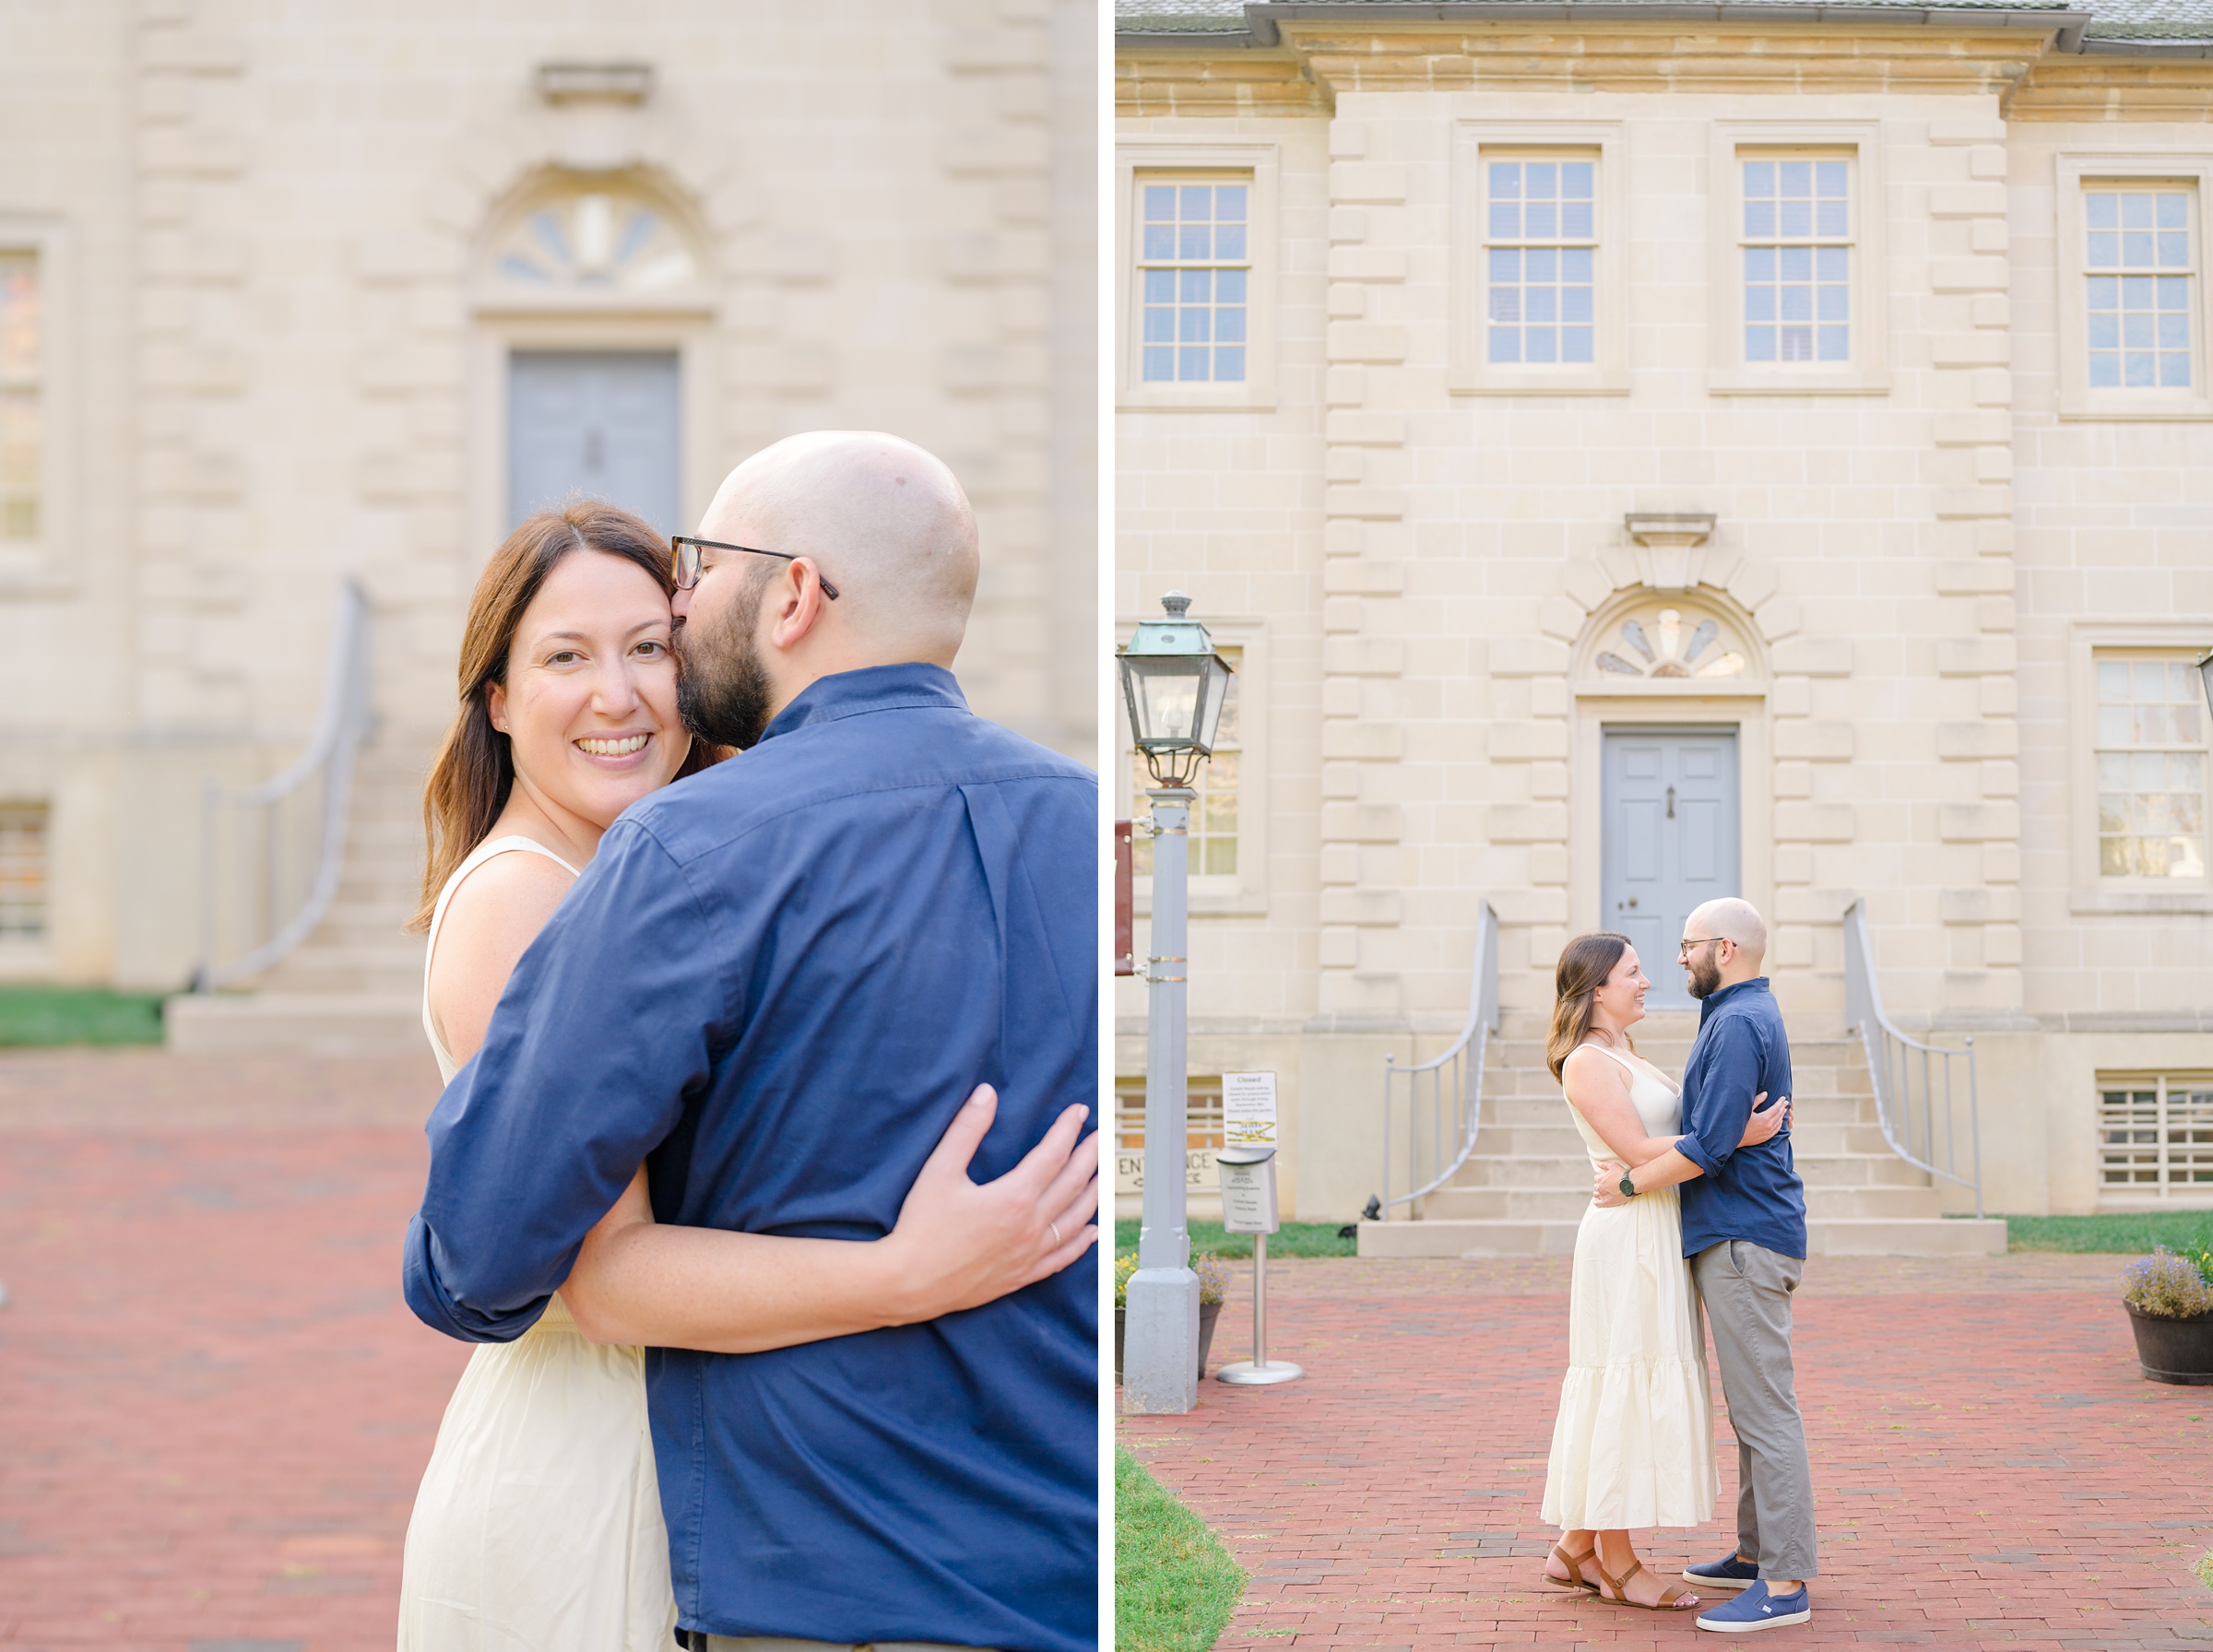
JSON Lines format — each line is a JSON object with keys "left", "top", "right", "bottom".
{"left": 1544, "top": 931, "right": 1788, "bottom": 1612}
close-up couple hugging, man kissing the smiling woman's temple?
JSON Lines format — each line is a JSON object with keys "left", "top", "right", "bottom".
{"left": 398, "top": 431, "right": 1097, "bottom": 1652}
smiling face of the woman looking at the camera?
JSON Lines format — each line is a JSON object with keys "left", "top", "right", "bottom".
{"left": 487, "top": 549, "right": 691, "bottom": 830}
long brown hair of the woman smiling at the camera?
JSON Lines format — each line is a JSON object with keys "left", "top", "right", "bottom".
{"left": 408, "top": 500, "right": 728, "bottom": 933}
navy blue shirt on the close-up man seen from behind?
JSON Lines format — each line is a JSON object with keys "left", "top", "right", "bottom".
{"left": 405, "top": 666, "right": 1100, "bottom": 1652}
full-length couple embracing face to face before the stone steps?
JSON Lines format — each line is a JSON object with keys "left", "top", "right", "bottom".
{"left": 1544, "top": 900, "right": 1817, "bottom": 1634}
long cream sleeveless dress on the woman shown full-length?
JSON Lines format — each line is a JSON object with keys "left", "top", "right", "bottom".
{"left": 1544, "top": 1044, "right": 1715, "bottom": 1530}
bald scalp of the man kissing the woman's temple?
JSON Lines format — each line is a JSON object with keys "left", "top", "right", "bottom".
{"left": 699, "top": 431, "right": 976, "bottom": 666}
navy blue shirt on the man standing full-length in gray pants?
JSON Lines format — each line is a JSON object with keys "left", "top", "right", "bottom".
{"left": 1675, "top": 975, "right": 1805, "bottom": 1258}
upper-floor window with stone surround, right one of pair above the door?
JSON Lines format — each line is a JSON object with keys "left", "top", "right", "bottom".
{"left": 1706, "top": 122, "right": 1888, "bottom": 395}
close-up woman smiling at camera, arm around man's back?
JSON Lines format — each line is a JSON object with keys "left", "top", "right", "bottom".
{"left": 398, "top": 502, "right": 1097, "bottom": 1652}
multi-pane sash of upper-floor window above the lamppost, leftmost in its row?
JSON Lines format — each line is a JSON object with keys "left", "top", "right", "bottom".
{"left": 1138, "top": 177, "right": 1252, "bottom": 384}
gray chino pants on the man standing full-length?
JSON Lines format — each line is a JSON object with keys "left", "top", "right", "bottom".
{"left": 1691, "top": 1238, "right": 1819, "bottom": 1576}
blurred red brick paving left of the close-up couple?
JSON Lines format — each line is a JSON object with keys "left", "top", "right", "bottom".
{"left": 0, "top": 1050, "right": 467, "bottom": 1652}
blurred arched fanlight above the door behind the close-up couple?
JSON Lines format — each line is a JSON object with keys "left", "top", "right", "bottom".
{"left": 491, "top": 183, "right": 704, "bottom": 296}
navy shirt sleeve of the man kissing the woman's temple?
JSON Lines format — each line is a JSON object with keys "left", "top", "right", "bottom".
{"left": 403, "top": 820, "right": 732, "bottom": 1342}
